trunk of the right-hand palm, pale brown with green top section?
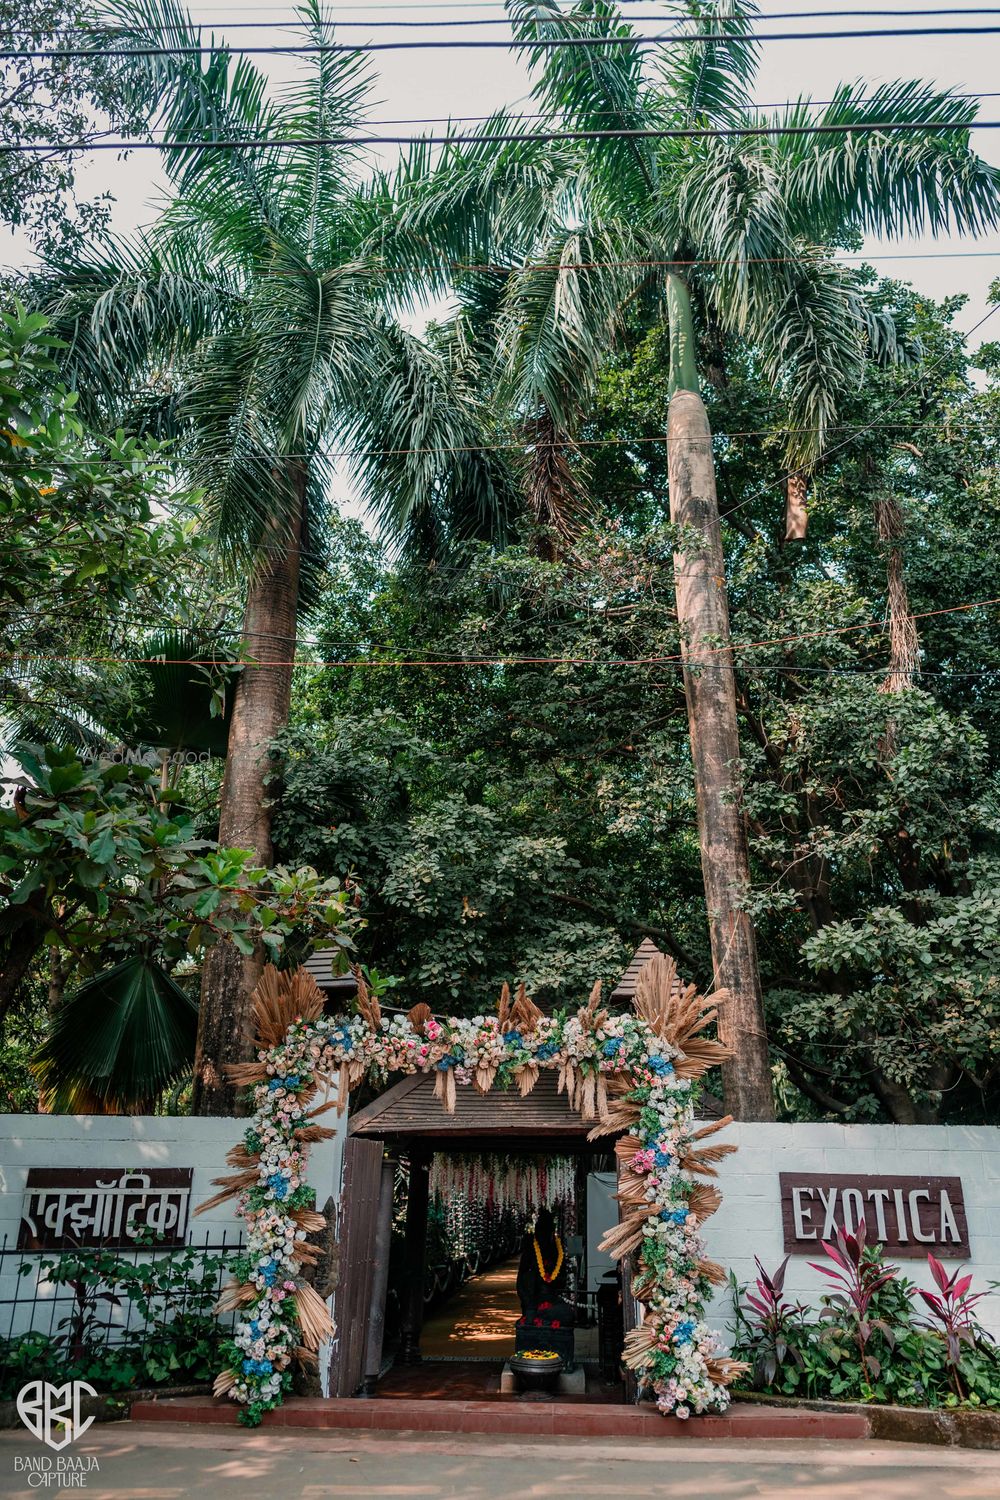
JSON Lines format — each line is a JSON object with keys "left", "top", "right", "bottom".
{"left": 667, "top": 278, "right": 774, "bottom": 1121}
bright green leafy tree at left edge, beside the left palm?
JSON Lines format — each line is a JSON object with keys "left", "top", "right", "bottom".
{"left": 0, "top": 305, "right": 225, "bottom": 749}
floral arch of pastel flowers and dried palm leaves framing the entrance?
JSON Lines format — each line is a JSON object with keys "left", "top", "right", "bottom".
{"left": 199, "top": 954, "right": 745, "bottom": 1425}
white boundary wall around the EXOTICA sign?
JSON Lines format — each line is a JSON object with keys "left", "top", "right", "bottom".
{"left": 703, "top": 1124, "right": 1000, "bottom": 1338}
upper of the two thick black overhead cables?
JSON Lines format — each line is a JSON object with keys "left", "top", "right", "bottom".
{"left": 9, "top": 26, "right": 1000, "bottom": 62}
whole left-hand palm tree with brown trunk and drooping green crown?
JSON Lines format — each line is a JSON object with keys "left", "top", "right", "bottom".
{"left": 39, "top": 0, "right": 511, "bottom": 1113}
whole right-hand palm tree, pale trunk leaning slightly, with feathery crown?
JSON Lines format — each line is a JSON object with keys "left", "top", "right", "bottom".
{"left": 394, "top": 0, "right": 1000, "bottom": 1119}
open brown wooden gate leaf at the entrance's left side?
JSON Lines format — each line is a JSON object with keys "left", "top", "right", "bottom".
{"left": 330, "top": 1136, "right": 382, "bottom": 1397}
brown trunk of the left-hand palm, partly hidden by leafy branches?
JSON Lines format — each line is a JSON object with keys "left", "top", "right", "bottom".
{"left": 192, "top": 470, "right": 306, "bottom": 1115}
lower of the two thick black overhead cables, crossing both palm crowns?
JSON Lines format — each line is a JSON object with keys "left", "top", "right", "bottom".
{"left": 0, "top": 117, "right": 1000, "bottom": 155}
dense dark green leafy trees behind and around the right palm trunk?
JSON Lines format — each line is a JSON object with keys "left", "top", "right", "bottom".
{"left": 274, "top": 273, "right": 1000, "bottom": 1121}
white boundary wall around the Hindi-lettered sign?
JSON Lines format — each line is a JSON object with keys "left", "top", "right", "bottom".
{"left": 0, "top": 1110, "right": 346, "bottom": 1335}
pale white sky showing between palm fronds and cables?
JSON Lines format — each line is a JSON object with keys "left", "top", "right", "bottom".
{"left": 0, "top": 0, "right": 1000, "bottom": 519}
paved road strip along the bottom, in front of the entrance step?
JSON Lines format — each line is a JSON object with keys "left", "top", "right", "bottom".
{"left": 0, "top": 1422, "right": 1000, "bottom": 1500}
